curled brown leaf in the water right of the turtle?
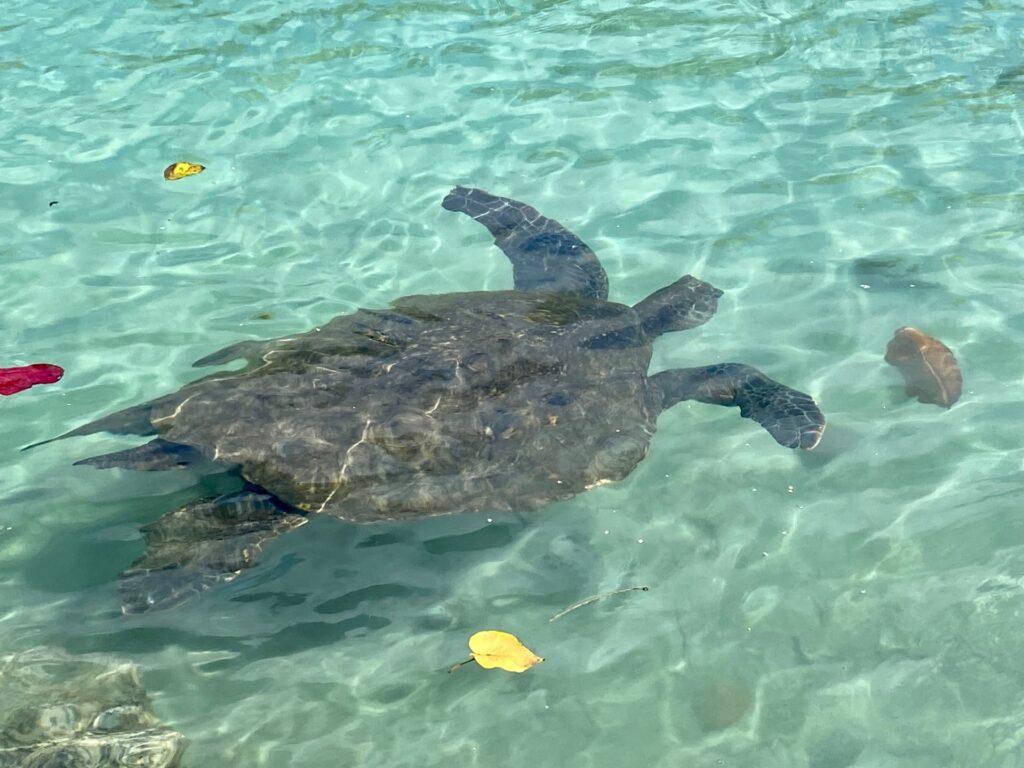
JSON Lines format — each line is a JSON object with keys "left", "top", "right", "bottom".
{"left": 886, "top": 326, "right": 964, "bottom": 408}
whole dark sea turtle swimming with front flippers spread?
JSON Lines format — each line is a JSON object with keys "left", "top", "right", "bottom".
{"left": 46, "top": 186, "right": 825, "bottom": 611}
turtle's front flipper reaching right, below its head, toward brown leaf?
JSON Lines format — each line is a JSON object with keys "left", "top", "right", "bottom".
{"left": 647, "top": 362, "right": 825, "bottom": 451}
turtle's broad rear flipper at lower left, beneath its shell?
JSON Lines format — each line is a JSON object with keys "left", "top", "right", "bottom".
{"left": 119, "top": 490, "right": 308, "bottom": 613}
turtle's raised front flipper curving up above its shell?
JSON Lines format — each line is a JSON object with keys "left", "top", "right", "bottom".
{"left": 441, "top": 186, "right": 608, "bottom": 299}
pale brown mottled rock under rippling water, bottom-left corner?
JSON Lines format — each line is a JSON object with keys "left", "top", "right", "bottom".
{"left": 0, "top": 647, "right": 185, "bottom": 768}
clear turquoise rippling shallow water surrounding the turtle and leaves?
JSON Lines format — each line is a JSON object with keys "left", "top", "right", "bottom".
{"left": 0, "top": 0, "right": 1024, "bottom": 768}
